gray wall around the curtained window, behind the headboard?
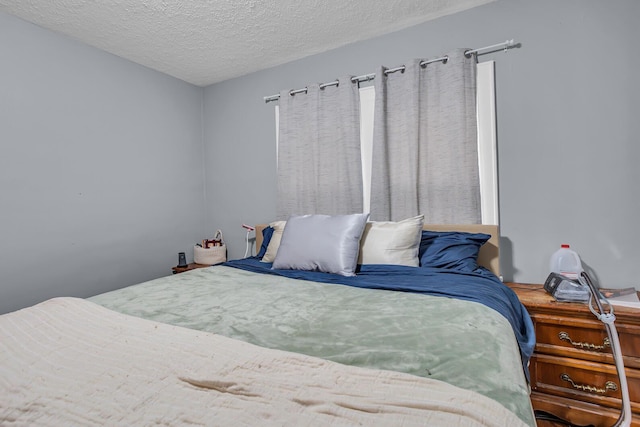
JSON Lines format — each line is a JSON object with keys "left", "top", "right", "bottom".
{"left": 204, "top": 0, "right": 640, "bottom": 287}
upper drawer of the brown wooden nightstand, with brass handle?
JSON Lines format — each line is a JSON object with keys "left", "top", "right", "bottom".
{"left": 532, "top": 314, "right": 640, "bottom": 368}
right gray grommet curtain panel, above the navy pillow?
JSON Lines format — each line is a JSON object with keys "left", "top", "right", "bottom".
{"left": 371, "top": 49, "right": 481, "bottom": 224}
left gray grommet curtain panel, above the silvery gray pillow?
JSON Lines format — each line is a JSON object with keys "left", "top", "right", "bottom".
{"left": 277, "top": 77, "right": 362, "bottom": 219}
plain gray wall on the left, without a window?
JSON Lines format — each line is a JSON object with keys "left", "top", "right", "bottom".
{"left": 0, "top": 13, "right": 204, "bottom": 313}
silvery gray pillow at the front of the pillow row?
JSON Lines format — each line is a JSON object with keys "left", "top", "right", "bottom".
{"left": 272, "top": 213, "right": 369, "bottom": 276}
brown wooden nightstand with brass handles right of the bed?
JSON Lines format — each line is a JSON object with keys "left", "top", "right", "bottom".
{"left": 506, "top": 283, "right": 640, "bottom": 427}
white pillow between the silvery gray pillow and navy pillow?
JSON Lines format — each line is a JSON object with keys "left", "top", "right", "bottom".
{"left": 358, "top": 215, "right": 424, "bottom": 267}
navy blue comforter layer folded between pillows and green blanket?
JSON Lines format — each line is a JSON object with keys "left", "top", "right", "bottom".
{"left": 223, "top": 257, "right": 535, "bottom": 379}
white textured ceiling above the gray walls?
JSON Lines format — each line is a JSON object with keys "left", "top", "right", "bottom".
{"left": 0, "top": 0, "right": 494, "bottom": 86}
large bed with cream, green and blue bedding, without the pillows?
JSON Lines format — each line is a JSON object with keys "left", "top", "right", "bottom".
{"left": 0, "top": 217, "right": 535, "bottom": 427}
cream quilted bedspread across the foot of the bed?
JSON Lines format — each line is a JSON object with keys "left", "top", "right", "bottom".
{"left": 0, "top": 298, "right": 524, "bottom": 427}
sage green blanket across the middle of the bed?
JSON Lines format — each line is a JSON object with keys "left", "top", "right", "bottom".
{"left": 90, "top": 266, "right": 535, "bottom": 426}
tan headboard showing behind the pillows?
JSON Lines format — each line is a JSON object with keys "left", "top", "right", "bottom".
{"left": 256, "top": 224, "right": 500, "bottom": 277}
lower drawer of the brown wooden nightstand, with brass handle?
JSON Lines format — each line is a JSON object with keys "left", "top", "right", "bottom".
{"left": 530, "top": 354, "right": 640, "bottom": 412}
